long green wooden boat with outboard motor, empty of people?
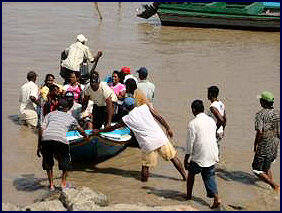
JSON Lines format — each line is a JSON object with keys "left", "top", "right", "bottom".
{"left": 137, "top": 2, "right": 280, "bottom": 31}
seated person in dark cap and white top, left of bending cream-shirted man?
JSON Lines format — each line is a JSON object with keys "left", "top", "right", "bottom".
{"left": 65, "top": 91, "right": 93, "bottom": 129}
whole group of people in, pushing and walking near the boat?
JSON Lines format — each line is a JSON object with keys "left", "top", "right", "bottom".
{"left": 19, "top": 34, "right": 280, "bottom": 208}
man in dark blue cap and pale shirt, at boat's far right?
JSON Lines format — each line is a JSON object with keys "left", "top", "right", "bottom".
{"left": 136, "top": 67, "right": 155, "bottom": 103}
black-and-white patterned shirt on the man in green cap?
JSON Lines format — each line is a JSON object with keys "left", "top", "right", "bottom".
{"left": 255, "top": 109, "right": 280, "bottom": 160}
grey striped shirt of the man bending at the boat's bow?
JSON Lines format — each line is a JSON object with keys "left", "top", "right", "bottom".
{"left": 42, "top": 111, "right": 79, "bottom": 144}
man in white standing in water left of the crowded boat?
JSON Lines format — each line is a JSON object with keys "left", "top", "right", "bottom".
{"left": 19, "top": 71, "right": 39, "bottom": 128}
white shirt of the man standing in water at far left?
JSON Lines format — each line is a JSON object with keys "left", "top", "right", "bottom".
{"left": 19, "top": 81, "right": 39, "bottom": 113}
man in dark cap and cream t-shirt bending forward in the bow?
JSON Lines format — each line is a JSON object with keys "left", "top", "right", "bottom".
{"left": 82, "top": 71, "right": 118, "bottom": 129}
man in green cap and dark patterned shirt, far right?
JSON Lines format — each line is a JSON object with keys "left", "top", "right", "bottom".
{"left": 252, "top": 91, "right": 280, "bottom": 191}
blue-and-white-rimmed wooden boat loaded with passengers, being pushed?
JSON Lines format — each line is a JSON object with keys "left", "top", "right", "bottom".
{"left": 67, "top": 128, "right": 131, "bottom": 163}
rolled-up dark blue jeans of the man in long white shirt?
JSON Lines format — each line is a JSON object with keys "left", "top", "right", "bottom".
{"left": 188, "top": 161, "right": 218, "bottom": 198}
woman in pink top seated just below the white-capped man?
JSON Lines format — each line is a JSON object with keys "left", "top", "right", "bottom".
{"left": 64, "top": 72, "right": 84, "bottom": 103}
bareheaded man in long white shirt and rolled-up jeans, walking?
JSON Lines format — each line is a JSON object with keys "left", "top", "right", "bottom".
{"left": 184, "top": 100, "right": 221, "bottom": 208}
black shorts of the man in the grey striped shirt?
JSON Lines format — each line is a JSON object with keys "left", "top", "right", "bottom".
{"left": 42, "top": 140, "right": 71, "bottom": 171}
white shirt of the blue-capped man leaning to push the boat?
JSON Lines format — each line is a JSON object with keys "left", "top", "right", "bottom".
{"left": 122, "top": 104, "right": 169, "bottom": 151}
